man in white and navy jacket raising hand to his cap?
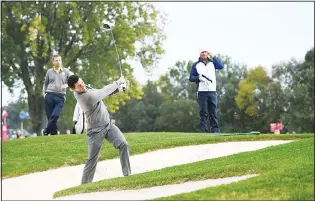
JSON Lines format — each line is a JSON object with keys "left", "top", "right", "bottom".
{"left": 189, "top": 50, "right": 223, "bottom": 133}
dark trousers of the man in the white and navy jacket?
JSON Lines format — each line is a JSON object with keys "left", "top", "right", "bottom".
{"left": 197, "top": 91, "right": 220, "bottom": 133}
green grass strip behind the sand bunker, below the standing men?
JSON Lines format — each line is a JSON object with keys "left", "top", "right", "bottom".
{"left": 2, "top": 133, "right": 314, "bottom": 179}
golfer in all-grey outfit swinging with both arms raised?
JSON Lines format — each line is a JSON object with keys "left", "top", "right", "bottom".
{"left": 68, "top": 75, "right": 131, "bottom": 184}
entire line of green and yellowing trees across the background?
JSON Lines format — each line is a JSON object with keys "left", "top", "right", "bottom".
{"left": 1, "top": 1, "right": 314, "bottom": 134}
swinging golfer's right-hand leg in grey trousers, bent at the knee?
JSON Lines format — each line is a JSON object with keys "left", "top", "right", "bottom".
{"left": 105, "top": 124, "right": 131, "bottom": 176}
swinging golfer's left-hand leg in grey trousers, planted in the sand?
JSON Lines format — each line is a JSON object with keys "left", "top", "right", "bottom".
{"left": 81, "top": 130, "right": 104, "bottom": 184}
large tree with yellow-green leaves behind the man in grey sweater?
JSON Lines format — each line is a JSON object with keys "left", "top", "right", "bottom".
{"left": 1, "top": 1, "right": 165, "bottom": 133}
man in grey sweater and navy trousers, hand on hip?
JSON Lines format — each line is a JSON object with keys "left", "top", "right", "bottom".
{"left": 43, "top": 55, "right": 73, "bottom": 135}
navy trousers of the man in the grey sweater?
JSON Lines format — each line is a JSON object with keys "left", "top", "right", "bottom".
{"left": 44, "top": 92, "right": 65, "bottom": 135}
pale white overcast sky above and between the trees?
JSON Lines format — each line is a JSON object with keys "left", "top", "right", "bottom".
{"left": 2, "top": 2, "right": 314, "bottom": 105}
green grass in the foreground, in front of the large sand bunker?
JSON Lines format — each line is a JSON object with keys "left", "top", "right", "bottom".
{"left": 54, "top": 135, "right": 314, "bottom": 200}
